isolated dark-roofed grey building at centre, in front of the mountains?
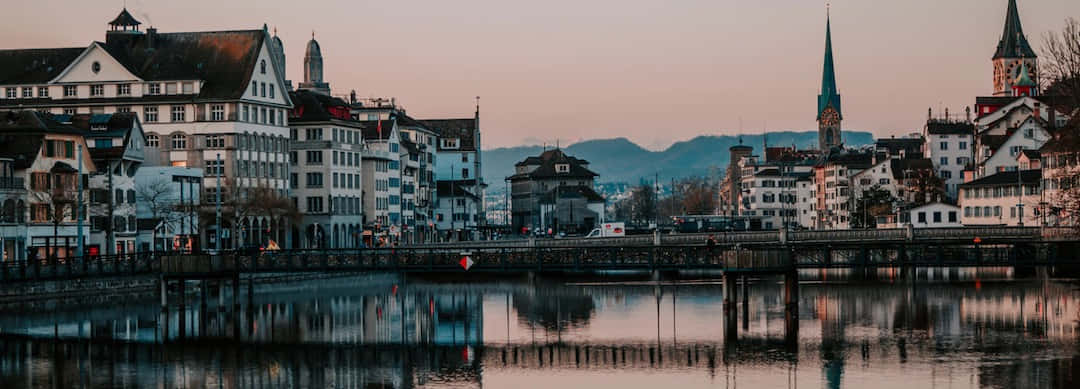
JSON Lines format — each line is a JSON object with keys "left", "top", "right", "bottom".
{"left": 507, "top": 149, "right": 604, "bottom": 232}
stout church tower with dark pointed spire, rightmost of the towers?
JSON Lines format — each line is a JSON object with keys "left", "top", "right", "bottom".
{"left": 994, "top": 0, "right": 1039, "bottom": 96}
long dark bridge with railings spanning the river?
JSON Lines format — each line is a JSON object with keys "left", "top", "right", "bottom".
{"left": 0, "top": 227, "right": 1080, "bottom": 283}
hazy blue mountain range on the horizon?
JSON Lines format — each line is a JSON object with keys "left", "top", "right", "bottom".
{"left": 483, "top": 131, "right": 874, "bottom": 191}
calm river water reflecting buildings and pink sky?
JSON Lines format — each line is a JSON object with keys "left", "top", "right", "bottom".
{"left": 0, "top": 269, "right": 1080, "bottom": 389}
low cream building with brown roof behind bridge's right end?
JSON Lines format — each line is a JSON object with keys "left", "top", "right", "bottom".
{"left": 960, "top": 170, "right": 1044, "bottom": 226}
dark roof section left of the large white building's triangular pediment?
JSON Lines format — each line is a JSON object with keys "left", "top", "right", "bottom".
{"left": 0, "top": 48, "right": 86, "bottom": 85}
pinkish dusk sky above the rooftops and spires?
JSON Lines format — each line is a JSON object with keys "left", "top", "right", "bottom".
{"left": 0, "top": 0, "right": 1080, "bottom": 149}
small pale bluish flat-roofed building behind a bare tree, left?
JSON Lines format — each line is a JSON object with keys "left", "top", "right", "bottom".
{"left": 134, "top": 166, "right": 201, "bottom": 252}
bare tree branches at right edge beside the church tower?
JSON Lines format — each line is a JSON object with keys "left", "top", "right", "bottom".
{"left": 1040, "top": 17, "right": 1080, "bottom": 112}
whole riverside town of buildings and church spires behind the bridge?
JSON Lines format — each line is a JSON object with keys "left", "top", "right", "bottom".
{"left": 0, "top": 0, "right": 1080, "bottom": 260}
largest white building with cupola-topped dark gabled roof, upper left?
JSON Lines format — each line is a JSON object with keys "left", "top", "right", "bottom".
{"left": 0, "top": 10, "right": 292, "bottom": 250}
